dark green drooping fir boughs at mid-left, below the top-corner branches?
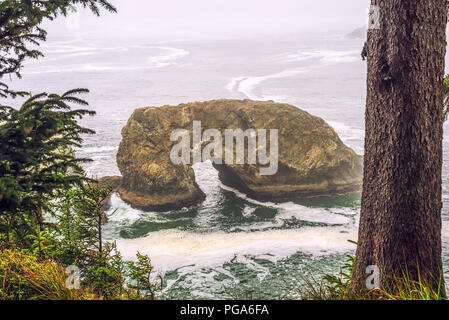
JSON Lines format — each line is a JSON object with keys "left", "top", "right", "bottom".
{"left": 0, "top": 89, "right": 95, "bottom": 246}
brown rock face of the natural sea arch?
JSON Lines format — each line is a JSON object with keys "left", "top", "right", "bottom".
{"left": 117, "top": 100, "right": 363, "bottom": 210}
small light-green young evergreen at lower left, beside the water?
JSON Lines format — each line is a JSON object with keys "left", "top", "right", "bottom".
{"left": 54, "top": 182, "right": 124, "bottom": 299}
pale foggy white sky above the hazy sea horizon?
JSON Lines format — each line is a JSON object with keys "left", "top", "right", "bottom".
{"left": 46, "top": 0, "right": 370, "bottom": 37}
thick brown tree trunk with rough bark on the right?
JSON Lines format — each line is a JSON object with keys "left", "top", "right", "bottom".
{"left": 351, "top": 0, "right": 447, "bottom": 292}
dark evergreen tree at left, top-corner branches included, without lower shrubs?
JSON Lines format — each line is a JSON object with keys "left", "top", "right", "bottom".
{"left": 0, "top": 0, "right": 115, "bottom": 248}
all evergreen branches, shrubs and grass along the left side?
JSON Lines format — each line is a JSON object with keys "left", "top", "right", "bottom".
{"left": 0, "top": 0, "right": 158, "bottom": 300}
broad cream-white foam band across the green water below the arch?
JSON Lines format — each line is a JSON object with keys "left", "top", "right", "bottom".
{"left": 116, "top": 227, "right": 357, "bottom": 274}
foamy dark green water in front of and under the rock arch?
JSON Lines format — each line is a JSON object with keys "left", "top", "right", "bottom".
{"left": 101, "top": 163, "right": 360, "bottom": 299}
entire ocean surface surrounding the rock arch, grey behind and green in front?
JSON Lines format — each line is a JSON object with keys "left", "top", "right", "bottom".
{"left": 9, "top": 34, "right": 449, "bottom": 299}
